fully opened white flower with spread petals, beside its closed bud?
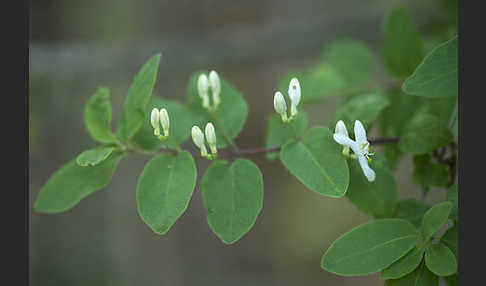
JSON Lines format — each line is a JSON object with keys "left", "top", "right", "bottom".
{"left": 333, "top": 120, "right": 376, "bottom": 182}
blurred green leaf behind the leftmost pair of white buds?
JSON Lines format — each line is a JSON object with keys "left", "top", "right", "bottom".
{"left": 133, "top": 96, "right": 198, "bottom": 152}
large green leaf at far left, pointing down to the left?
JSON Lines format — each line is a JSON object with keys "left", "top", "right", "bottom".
{"left": 34, "top": 153, "right": 123, "bottom": 213}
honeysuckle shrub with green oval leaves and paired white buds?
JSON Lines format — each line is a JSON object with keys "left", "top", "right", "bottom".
{"left": 34, "top": 5, "right": 458, "bottom": 286}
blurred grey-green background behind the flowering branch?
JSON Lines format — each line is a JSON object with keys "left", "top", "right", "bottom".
{"left": 29, "top": 0, "right": 451, "bottom": 286}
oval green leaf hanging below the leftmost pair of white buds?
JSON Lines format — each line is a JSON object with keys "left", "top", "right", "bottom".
{"left": 137, "top": 151, "right": 197, "bottom": 234}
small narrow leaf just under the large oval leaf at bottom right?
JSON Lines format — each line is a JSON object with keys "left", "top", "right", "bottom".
{"left": 380, "top": 245, "right": 424, "bottom": 280}
